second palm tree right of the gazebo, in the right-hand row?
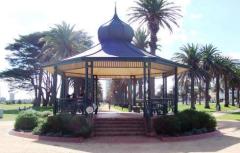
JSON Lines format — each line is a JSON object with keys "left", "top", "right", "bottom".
{"left": 200, "top": 44, "right": 219, "bottom": 109}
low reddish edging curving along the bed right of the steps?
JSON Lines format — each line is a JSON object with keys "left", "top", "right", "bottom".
{"left": 157, "top": 130, "right": 222, "bottom": 142}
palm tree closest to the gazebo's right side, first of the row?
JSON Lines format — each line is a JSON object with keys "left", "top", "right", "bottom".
{"left": 174, "top": 44, "right": 205, "bottom": 109}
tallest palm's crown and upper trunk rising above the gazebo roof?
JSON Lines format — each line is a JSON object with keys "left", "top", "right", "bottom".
{"left": 129, "top": 0, "right": 181, "bottom": 55}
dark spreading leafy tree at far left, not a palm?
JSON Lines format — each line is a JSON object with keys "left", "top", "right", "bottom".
{"left": 0, "top": 33, "right": 45, "bottom": 106}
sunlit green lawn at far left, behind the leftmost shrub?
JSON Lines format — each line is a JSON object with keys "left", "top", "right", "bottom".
{"left": 0, "top": 104, "right": 52, "bottom": 121}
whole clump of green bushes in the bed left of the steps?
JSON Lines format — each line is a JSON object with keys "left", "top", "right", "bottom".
{"left": 14, "top": 110, "right": 92, "bottom": 138}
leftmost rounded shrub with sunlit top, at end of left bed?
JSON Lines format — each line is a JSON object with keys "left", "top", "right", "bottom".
{"left": 14, "top": 110, "right": 38, "bottom": 131}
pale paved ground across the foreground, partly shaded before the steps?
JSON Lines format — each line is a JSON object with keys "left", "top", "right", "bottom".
{"left": 0, "top": 121, "right": 240, "bottom": 153}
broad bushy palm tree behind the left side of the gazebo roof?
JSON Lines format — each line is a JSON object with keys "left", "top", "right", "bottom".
{"left": 41, "top": 22, "right": 93, "bottom": 102}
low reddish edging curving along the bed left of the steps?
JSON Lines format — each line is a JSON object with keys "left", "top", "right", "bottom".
{"left": 9, "top": 130, "right": 84, "bottom": 143}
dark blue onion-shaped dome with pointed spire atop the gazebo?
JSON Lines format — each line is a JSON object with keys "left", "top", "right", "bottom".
{"left": 98, "top": 9, "right": 134, "bottom": 43}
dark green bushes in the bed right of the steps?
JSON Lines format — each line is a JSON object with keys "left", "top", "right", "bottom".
{"left": 154, "top": 109, "right": 217, "bottom": 136}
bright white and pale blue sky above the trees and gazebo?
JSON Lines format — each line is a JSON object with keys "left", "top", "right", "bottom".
{"left": 0, "top": 0, "right": 240, "bottom": 99}
